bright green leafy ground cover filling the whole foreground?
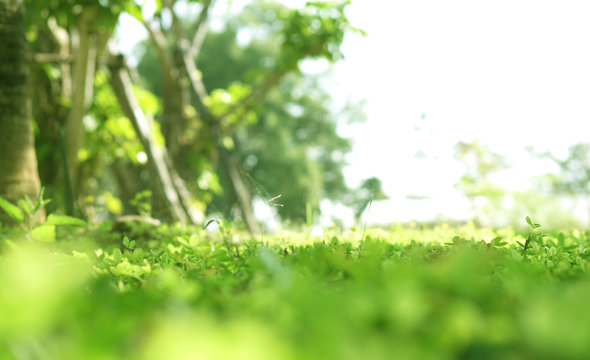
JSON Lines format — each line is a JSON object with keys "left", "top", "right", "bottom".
{"left": 0, "top": 222, "right": 590, "bottom": 359}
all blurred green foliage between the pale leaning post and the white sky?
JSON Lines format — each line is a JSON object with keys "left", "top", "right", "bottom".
{"left": 138, "top": 1, "right": 362, "bottom": 222}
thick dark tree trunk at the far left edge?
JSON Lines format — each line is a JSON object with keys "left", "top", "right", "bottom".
{"left": 0, "top": 0, "right": 44, "bottom": 220}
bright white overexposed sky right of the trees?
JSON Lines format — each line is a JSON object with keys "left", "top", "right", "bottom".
{"left": 117, "top": 0, "right": 590, "bottom": 223}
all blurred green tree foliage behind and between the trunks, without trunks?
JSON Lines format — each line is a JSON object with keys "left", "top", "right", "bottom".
{"left": 26, "top": 0, "right": 368, "bottom": 221}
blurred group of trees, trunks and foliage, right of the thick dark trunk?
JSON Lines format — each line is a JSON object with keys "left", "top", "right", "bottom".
{"left": 17, "top": 0, "right": 374, "bottom": 228}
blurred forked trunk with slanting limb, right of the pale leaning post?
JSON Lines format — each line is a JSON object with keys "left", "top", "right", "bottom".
{"left": 143, "top": 0, "right": 264, "bottom": 232}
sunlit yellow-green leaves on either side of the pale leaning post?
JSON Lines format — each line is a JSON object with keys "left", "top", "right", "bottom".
{"left": 78, "top": 73, "right": 170, "bottom": 216}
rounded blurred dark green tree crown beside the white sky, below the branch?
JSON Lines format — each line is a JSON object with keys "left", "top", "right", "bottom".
{"left": 236, "top": 72, "right": 358, "bottom": 222}
